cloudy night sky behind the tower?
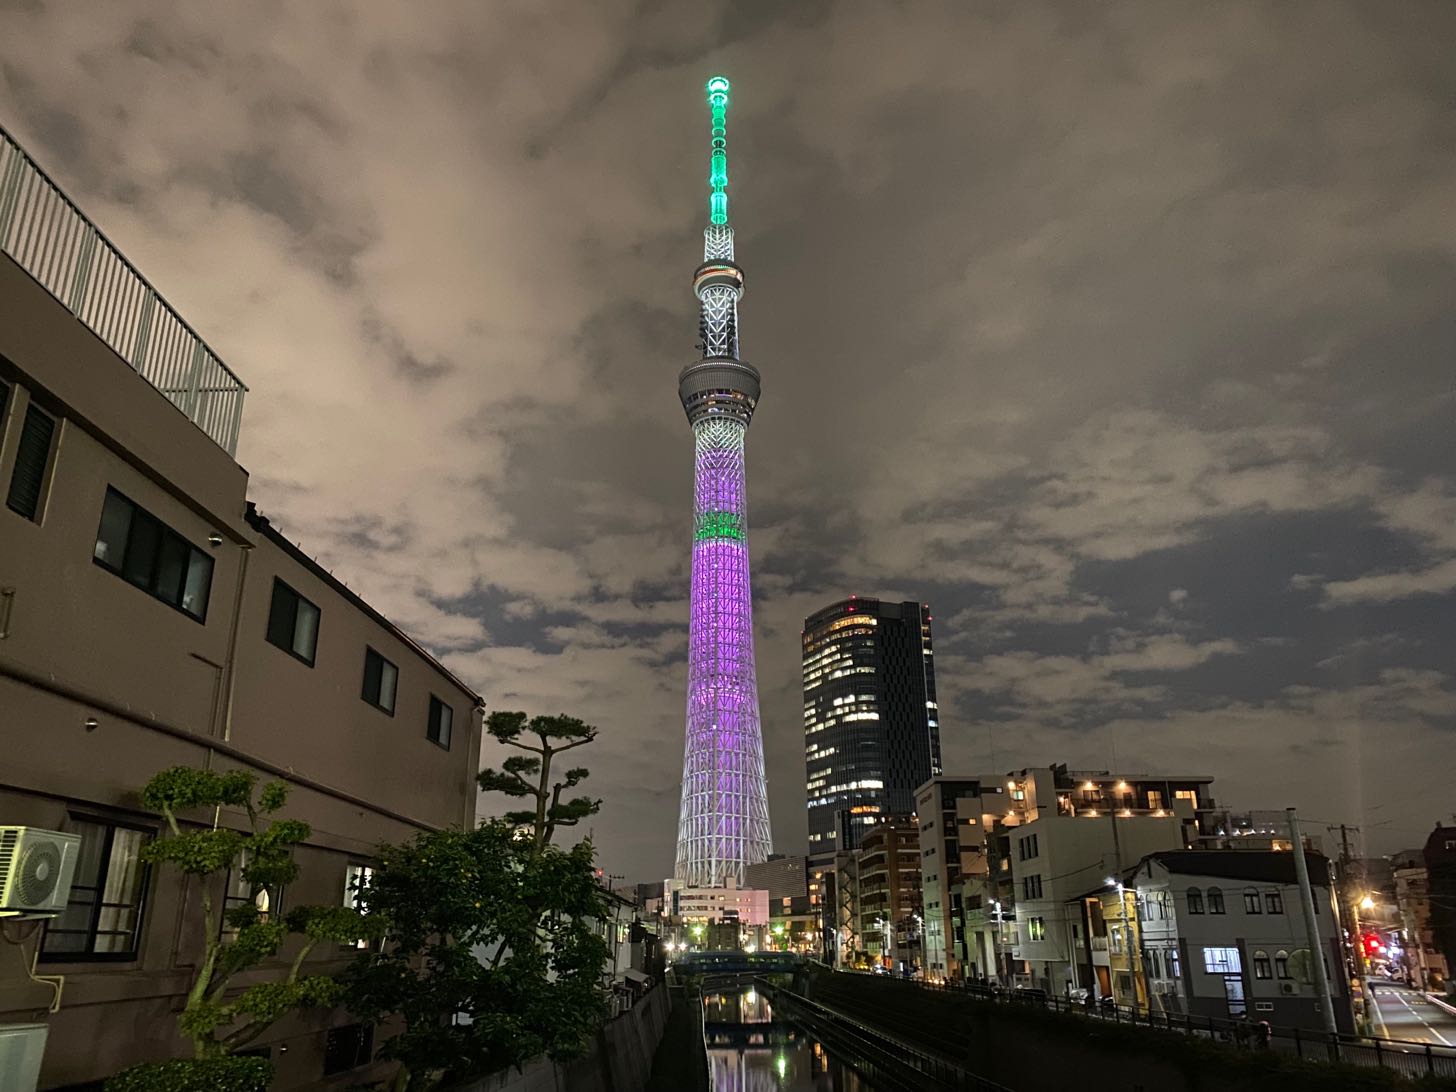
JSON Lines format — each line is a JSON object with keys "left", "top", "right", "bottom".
{"left": 0, "top": 0, "right": 1456, "bottom": 878}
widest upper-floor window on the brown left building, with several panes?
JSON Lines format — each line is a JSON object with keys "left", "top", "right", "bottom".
{"left": 92, "top": 489, "right": 213, "bottom": 622}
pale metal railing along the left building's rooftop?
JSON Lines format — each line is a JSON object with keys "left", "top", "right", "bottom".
{"left": 0, "top": 127, "right": 248, "bottom": 456}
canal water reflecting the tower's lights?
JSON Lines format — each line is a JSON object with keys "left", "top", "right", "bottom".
{"left": 703, "top": 989, "right": 875, "bottom": 1092}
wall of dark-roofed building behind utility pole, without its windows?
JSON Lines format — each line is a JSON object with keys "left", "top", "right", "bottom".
{"left": 1137, "top": 860, "right": 1354, "bottom": 1032}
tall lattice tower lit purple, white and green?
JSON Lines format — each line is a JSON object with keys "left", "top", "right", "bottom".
{"left": 674, "top": 76, "right": 770, "bottom": 887}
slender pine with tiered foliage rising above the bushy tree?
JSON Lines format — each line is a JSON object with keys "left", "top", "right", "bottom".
{"left": 478, "top": 712, "right": 601, "bottom": 849}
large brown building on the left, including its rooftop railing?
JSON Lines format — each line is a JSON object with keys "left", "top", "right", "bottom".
{"left": 0, "top": 131, "right": 482, "bottom": 1089}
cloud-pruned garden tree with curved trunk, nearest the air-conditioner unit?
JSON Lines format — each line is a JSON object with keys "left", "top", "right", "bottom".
{"left": 133, "top": 766, "right": 365, "bottom": 1059}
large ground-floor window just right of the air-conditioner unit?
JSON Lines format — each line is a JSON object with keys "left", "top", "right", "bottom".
{"left": 41, "top": 818, "right": 151, "bottom": 962}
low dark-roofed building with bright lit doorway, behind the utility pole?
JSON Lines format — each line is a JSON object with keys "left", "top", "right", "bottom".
{"left": 1129, "top": 850, "right": 1354, "bottom": 1034}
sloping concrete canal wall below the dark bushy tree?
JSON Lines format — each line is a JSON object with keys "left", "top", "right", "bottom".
{"left": 451, "top": 984, "right": 670, "bottom": 1092}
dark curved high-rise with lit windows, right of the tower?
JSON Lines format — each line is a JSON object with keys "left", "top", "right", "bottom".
{"left": 804, "top": 596, "right": 941, "bottom": 862}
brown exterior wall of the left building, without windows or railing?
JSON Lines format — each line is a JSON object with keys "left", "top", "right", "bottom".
{"left": 0, "top": 256, "right": 480, "bottom": 1089}
